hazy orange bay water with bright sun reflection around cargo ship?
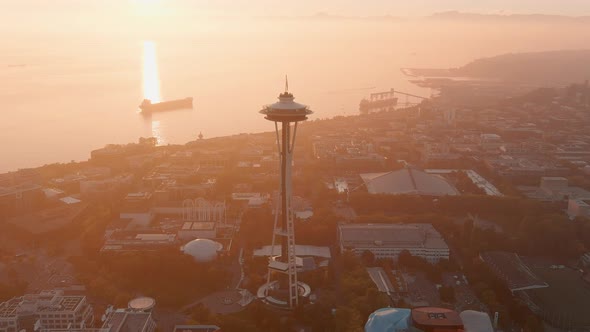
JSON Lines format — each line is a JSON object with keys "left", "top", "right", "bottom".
{"left": 0, "top": 13, "right": 590, "bottom": 171}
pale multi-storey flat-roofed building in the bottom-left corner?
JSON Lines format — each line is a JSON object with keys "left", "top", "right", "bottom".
{"left": 0, "top": 290, "right": 94, "bottom": 332}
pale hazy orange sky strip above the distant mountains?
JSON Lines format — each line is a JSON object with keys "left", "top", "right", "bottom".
{"left": 0, "top": 0, "right": 590, "bottom": 16}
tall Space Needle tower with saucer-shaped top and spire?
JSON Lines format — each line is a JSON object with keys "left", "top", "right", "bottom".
{"left": 259, "top": 77, "right": 313, "bottom": 308}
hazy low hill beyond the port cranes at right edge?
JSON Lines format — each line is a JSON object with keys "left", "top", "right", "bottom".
{"left": 449, "top": 50, "right": 590, "bottom": 86}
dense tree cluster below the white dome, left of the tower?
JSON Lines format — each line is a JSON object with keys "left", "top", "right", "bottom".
{"left": 70, "top": 248, "right": 230, "bottom": 307}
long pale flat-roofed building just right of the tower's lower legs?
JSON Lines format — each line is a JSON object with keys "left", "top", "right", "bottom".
{"left": 338, "top": 224, "right": 449, "bottom": 264}
